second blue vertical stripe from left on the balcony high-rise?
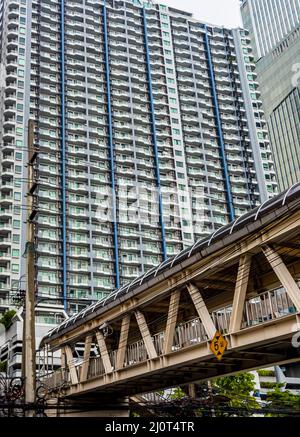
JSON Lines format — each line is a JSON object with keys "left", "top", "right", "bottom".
{"left": 103, "top": 2, "right": 120, "bottom": 288}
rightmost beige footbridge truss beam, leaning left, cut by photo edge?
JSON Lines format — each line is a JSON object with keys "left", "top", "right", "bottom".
{"left": 262, "top": 244, "right": 300, "bottom": 312}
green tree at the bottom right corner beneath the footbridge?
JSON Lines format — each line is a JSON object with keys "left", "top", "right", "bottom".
{"left": 267, "top": 384, "right": 300, "bottom": 417}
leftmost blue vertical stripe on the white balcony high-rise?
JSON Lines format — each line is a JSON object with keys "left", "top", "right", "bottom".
{"left": 60, "top": 0, "right": 67, "bottom": 310}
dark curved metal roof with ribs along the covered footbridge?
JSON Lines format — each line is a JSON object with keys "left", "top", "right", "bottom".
{"left": 41, "top": 182, "right": 300, "bottom": 345}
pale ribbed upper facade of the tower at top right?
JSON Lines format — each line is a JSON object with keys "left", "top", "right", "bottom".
{"left": 240, "top": 0, "right": 300, "bottom": 61}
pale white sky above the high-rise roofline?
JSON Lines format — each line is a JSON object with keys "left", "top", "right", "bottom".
{"left": 155, "top": 0, "right": 242, "bottom": 28}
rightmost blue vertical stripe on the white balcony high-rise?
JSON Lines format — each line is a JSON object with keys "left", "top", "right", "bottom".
{"left": 204, "top": 25, "right": 235, "bottom": 221}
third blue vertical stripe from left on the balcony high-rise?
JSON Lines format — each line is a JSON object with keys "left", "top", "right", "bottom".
{"left": 142, "top": 7, "right": 167, "bottom": 261}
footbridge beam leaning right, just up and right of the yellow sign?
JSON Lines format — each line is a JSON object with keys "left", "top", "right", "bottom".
{"left": 229, "top": 254, "right": 252, "bottom": 333}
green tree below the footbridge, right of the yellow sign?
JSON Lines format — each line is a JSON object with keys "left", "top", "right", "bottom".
{"left": 213, "top": 373, "right": 260, "bottom": 415}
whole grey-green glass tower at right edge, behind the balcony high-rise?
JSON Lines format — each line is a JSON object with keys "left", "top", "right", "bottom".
{"left": 241, "top": 0, "right": 300, "bottom": 191}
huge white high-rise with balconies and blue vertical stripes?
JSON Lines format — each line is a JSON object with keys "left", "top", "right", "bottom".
{"left": 0, "top": 0, "right": 276, "bottom": 312}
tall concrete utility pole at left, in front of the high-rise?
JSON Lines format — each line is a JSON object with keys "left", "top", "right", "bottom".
{"left": 22, "top": 120, "right": 37, "bottom": 416}
